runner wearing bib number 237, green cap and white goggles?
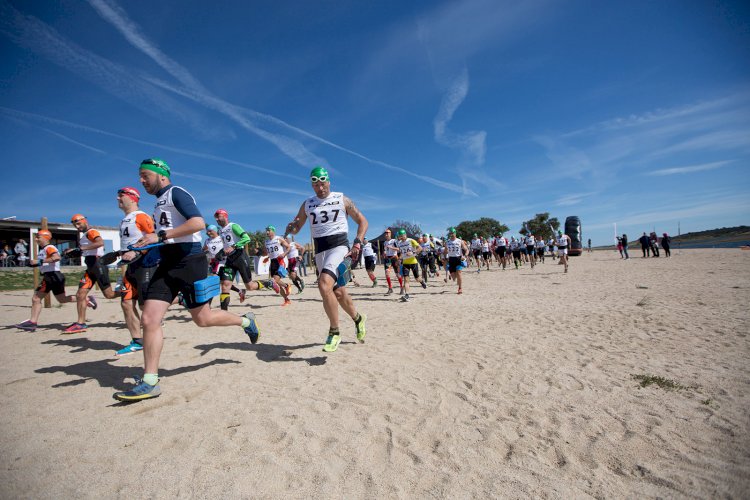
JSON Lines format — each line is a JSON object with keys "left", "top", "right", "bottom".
{"left": 286, "top": 167, "right": 367, "bottom": 352}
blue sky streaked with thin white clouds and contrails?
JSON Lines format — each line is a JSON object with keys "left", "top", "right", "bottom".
{"left": 0, "top": 0, "right": 750, "bottom": 245}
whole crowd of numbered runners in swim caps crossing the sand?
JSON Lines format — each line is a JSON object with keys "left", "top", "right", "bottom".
{"left": 10, "top": 158, "right": 570, "bottom": 402}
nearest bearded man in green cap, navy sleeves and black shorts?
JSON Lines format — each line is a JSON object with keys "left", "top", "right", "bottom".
{"left": 113, "top": 158, "right": 260, "bottom": 401}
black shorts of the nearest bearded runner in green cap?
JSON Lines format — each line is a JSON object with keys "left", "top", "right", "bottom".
{"left": 144, "top": 253, "right": 208, "bottom": 309}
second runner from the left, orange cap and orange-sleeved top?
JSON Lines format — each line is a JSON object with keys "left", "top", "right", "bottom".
{"left": 63, "top": 214, "right": 117, "bottom": 333}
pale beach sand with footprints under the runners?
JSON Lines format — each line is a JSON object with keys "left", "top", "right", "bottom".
{"left": 0, "top": 249, "right": 750, "bottom": 498}
